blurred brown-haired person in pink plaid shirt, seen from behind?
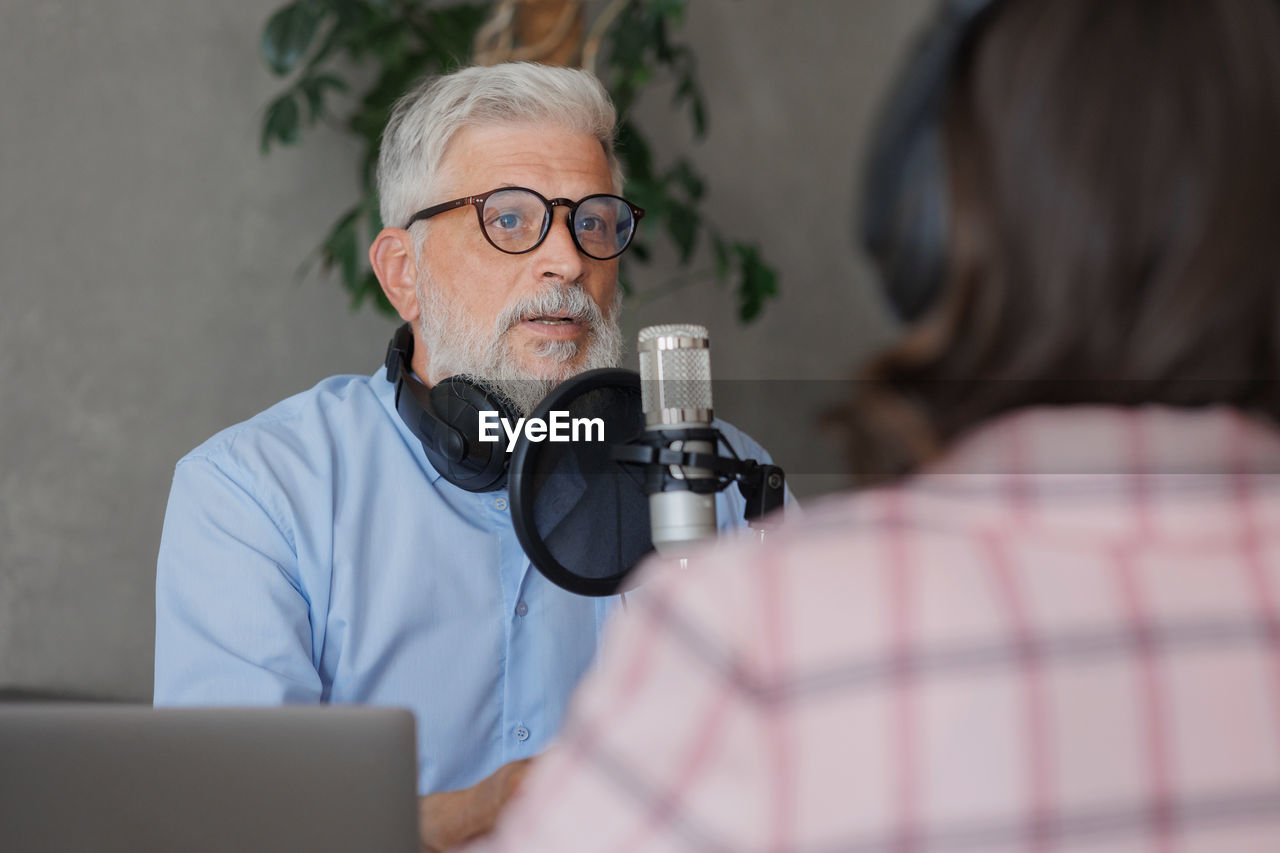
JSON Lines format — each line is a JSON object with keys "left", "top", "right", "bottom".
{"left": 465, "top": 0, "right": 1280, "bottom": 852}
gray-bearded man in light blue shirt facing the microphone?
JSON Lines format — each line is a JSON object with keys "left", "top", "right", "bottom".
{"left": 155, "top": 63, "right": 768, "bottom": 847}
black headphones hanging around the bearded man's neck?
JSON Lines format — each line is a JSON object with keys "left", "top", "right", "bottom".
{"left": 387, "top": 323, "right": 518, "bottom": 492}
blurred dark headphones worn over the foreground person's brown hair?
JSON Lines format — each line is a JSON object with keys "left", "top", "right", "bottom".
{"left": 860, "top": 0, "right": 1001, "bottom": 323}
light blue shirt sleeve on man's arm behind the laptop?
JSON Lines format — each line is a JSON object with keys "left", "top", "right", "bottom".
{"left": 155, "top": 456, "right": 321, "bottom": 706}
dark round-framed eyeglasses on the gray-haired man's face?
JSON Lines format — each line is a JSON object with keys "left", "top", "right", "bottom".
{"left": 404, "top": 187, "right": 644, "bottom": 260}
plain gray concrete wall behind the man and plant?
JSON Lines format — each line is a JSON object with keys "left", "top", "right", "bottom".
{"left": 0, "top": 0, "right": 925, "bottom": 699}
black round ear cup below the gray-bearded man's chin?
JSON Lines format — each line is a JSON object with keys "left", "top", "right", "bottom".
{"left": 430, "top": 377, "right": 520, "bottom": 492}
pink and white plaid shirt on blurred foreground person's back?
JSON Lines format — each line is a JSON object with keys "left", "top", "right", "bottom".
{"left": 468, "top": 409, "right": 1280, "bottom": 853}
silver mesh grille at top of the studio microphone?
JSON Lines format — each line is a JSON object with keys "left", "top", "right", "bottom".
{"left": 636, "top": 323, "right": 712, "bottom": 427}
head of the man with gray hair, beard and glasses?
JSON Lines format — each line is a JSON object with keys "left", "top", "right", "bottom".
{"left": 369, "top": 63, "right": 629, "bottom": 412}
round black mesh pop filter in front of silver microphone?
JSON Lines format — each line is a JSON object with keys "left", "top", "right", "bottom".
{"left": 508, "top": 368, "right": 653, "bottom": 596}
